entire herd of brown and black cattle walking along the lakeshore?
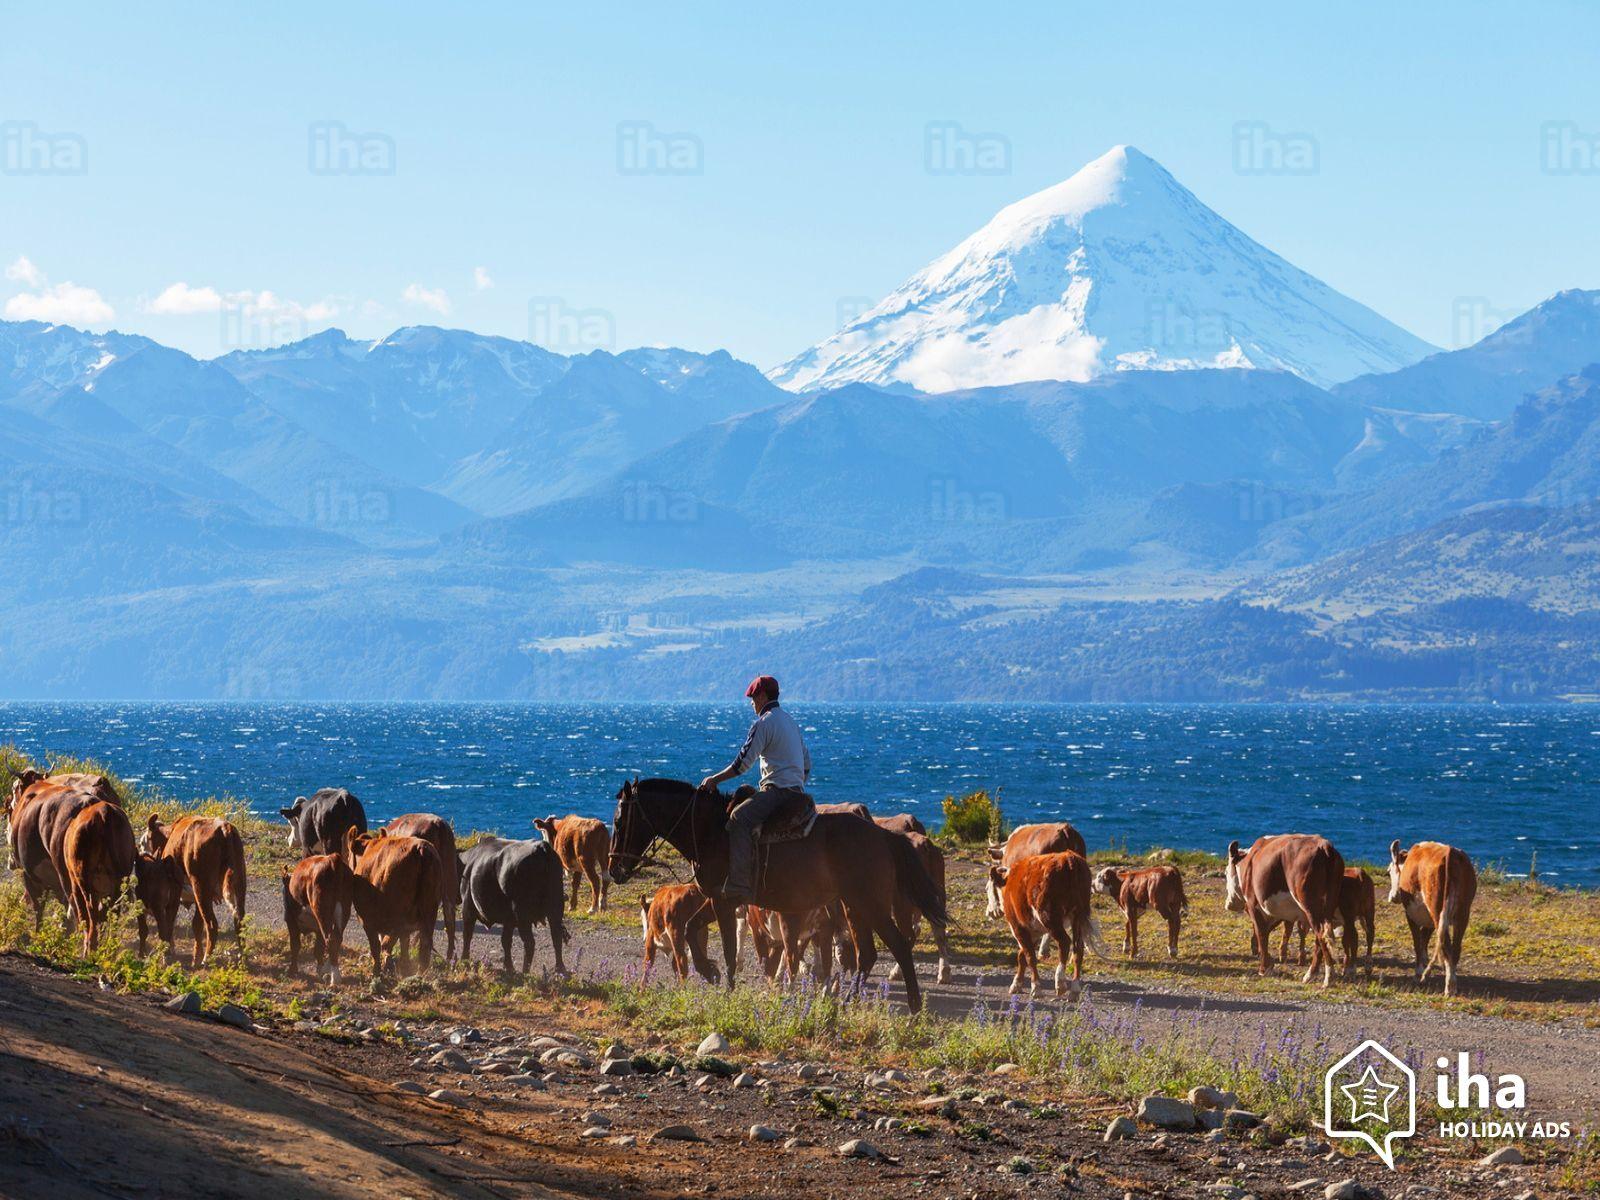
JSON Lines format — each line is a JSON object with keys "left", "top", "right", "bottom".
{"left": 6, "top": 771, "right": 1477, "bottom": 995}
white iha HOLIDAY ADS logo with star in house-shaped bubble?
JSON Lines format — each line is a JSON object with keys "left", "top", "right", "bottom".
{"left": 1323, "top": 1038, "right": 1571, "bottom": 1170}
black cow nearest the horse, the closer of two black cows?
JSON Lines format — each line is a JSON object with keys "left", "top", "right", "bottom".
{"left": 461, "top": 837, "right": 571, "bottom": 974}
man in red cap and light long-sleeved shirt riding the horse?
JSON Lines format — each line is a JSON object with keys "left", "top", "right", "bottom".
{"left": 701, "top": 675, "right": 813, "bottom": 904}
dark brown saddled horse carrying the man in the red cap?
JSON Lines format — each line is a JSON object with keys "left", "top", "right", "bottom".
{"left": 608, "top": 779, "right": 946, "bottom": 1013}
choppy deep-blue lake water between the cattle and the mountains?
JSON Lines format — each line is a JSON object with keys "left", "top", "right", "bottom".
{"left": 0, "top": 702, "right": 1600, "bottom": 886}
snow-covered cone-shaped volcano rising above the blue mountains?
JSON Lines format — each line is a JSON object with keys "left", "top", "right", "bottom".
{"left": 771, "top": 146, "right": 1434, "bottom": 392}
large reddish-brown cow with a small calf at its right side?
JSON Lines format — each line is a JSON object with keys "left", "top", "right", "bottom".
{"left": 1226, "top": 834, "right": 1344, "bottom": 987}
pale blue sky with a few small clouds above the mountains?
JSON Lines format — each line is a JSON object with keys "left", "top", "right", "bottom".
{"left": 0, "top": 2, "right": 1600, "bottom": 366}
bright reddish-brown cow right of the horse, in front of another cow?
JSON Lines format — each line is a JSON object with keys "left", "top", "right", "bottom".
{"left": 989, "top": 850, "right": 1104, "bottom": 1000}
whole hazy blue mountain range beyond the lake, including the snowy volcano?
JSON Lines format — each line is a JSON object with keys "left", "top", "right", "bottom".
{"left": 0, "top": 147, "right": 1600, "bottom": 699}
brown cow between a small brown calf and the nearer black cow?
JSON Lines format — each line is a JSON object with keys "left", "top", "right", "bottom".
{"left": 344, "top": 829, "right": 443, "bottom": 976}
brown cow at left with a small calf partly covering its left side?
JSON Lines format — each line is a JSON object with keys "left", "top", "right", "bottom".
{"left": 139, "top": 813, "right": 250, "bottom": 966}
